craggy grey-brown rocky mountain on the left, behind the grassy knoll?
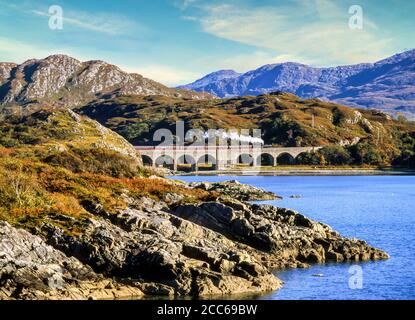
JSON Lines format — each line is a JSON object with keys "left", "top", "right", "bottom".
{"left": 0, "top": 55, "right": 209, "bottom": 114}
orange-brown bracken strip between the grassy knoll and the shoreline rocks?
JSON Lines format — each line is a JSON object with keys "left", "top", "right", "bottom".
{"left": 0, "top": 156, "right": 215, "bottom": 235}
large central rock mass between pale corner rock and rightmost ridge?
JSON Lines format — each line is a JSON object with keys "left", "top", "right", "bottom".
{"left": 35, "top": 198, "right": 281, "bottom": 296}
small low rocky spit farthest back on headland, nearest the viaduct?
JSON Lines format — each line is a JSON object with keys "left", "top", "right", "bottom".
{"left": 190, "top": 180, "right": 282, "bottom": 201}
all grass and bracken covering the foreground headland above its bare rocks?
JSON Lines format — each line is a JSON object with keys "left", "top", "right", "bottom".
{"left": 0, "top": 111, "right": 217, "bottom": 235}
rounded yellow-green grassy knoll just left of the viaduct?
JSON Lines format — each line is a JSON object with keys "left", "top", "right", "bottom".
{"left": 0, "top": 109, "right": 146, "bottom": 176}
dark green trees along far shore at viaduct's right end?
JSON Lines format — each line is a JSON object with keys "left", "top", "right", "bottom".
{"left": 296, "top": 133, "right": 415, "bottom": 167}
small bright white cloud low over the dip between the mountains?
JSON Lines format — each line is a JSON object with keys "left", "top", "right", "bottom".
{"left": 130, "top": 64, "right": 200, "bottom": 87}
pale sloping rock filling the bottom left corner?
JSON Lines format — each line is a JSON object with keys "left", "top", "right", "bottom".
{"left": 0, "top": 222, "right": 143, "bottom": 299}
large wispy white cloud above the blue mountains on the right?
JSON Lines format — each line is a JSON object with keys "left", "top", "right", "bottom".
{"left": 193, "top": 0, "right": 393, "bottom": 66}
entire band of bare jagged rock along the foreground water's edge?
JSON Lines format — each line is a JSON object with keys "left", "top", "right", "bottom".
{"left": 0, "top": 182, "right": 388, "bottom": 299}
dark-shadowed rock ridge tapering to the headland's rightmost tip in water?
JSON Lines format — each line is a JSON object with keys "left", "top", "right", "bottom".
{"left": 174, "top": 200, "right": 388, "bottom": 268}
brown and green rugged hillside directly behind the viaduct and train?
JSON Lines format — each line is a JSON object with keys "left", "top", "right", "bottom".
{"left": 77, "top": 92, "right": 415, "bottom": 162}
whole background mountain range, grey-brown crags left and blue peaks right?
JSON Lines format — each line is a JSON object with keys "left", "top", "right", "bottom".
{"left": 0, "top": 50, "right": 415, "bottom": 118}
